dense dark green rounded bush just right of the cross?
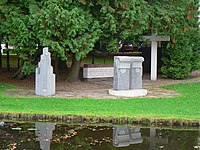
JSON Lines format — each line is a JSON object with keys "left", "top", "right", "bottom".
{"left": 161, "top": 34, "right": 193, "bottom": 79}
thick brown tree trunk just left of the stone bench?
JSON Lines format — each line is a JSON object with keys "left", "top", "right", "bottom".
{"left": 67, "top": 55, "right": 81, "bottom": 82}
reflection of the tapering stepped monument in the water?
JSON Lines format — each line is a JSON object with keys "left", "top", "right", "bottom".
{"left": 35, "top": 122, "right": 55, "bottom": 150}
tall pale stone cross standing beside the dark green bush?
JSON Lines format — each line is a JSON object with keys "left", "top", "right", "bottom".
{"left": 143, "top": 35, "right": 170, "bottom": 80}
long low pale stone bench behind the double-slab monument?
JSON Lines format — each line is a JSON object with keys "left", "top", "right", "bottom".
{"left": 83, "top": 64, "right": 114, "bottom": 79}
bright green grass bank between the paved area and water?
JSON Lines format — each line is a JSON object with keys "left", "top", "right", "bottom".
{"left": 0, "top": 82, "right": 200, "bottom": 121}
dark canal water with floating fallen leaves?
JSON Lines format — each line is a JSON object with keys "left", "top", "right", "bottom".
{"left": 0, "top": 121, "right": 200, "bottom": 150}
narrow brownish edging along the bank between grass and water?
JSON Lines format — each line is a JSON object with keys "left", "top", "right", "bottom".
{"left": 0, "top": 113, "right": 200, "bottom": 128}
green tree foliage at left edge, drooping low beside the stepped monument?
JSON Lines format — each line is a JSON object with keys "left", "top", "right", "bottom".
{"left": 0, "top": 0, "right": 40, "bottom": 79}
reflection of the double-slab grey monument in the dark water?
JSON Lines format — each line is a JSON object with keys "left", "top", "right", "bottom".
{"left": 113, "top": 126, "right": 143, "bottom": 147}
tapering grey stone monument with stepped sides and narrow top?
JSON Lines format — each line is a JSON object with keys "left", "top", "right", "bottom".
{"left": 35, "top": 47, "right": 55, "bottom": 96}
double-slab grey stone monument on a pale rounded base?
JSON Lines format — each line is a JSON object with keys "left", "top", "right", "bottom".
{"left": 109, "top": 56, "right": 147, "bottom": 97}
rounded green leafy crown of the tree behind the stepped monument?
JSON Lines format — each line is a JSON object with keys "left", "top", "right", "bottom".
{"left": 31, "top": 0, "right": 101, "bottom": 60}
